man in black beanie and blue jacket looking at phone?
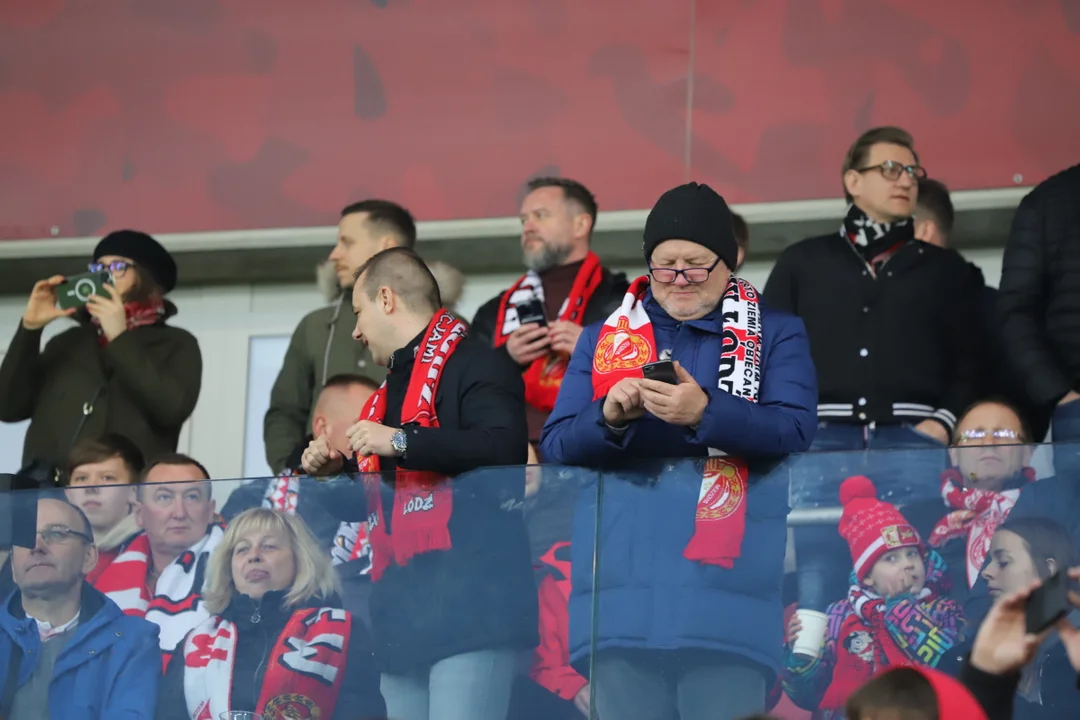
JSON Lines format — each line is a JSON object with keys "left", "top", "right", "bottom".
{"left": 541, "top": 182, "right": 818, "bottom": 720}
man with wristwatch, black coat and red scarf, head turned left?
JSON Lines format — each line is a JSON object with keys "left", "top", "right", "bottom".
{"left": 303, "top": 248, "right": 538, "bottom": 720}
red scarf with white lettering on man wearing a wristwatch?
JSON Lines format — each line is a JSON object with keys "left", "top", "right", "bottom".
{"left": 356, "top": 310, "right": 468, "bottom": 582}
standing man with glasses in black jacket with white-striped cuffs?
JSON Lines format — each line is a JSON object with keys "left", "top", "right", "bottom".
{"left": 765, "top": 127, "right": 980, "bottom": 611}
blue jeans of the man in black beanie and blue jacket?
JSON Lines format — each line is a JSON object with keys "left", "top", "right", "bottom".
{"left": 593, "top": 650, "right": 766, "bottom": 720}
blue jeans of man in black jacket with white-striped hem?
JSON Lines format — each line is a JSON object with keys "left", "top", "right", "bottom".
{"left": 789, "top": 422, "right": 947, "bottom": 612}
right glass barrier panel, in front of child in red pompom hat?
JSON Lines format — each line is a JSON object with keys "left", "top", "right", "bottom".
{"left": 587, "top": 444, "right": 1080, "bottom": 720}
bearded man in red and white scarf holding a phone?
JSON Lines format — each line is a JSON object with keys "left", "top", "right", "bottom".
{"left": 471, "top": 177, "right": 629, "bottom": 443}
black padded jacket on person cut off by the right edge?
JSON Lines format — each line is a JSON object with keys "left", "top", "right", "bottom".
{"left": 998, "top": 165, "right": 1080, "bottom": 406}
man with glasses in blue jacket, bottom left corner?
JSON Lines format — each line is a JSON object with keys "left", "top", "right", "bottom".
{"left": 0, "top": 499, "right": 161, "bottom": 720}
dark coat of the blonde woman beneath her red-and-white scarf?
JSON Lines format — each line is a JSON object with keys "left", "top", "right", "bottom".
{"left": 154, "top": 592, "right": 387, "bottom": 720}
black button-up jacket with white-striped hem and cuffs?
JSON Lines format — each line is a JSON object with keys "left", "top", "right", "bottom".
{"left": 765, "top": 233, "right": 983, "bottom": 430}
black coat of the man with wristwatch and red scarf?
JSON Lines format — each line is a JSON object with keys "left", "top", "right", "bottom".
{"left": 357, "top": 336, "right": 538, "bottom": 675}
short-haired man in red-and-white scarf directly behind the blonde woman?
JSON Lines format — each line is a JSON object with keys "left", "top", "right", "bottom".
{"left": 95, "top": 453, "right": 224, "bottom": 669}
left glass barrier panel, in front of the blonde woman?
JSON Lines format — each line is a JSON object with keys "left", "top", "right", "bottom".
{"left": 0, "top": 465, "right": 598, "bottom": 720}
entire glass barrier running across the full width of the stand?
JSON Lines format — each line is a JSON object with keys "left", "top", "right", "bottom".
{"left": 6, "top": 446, "right": 1080, "bottom": 720}
